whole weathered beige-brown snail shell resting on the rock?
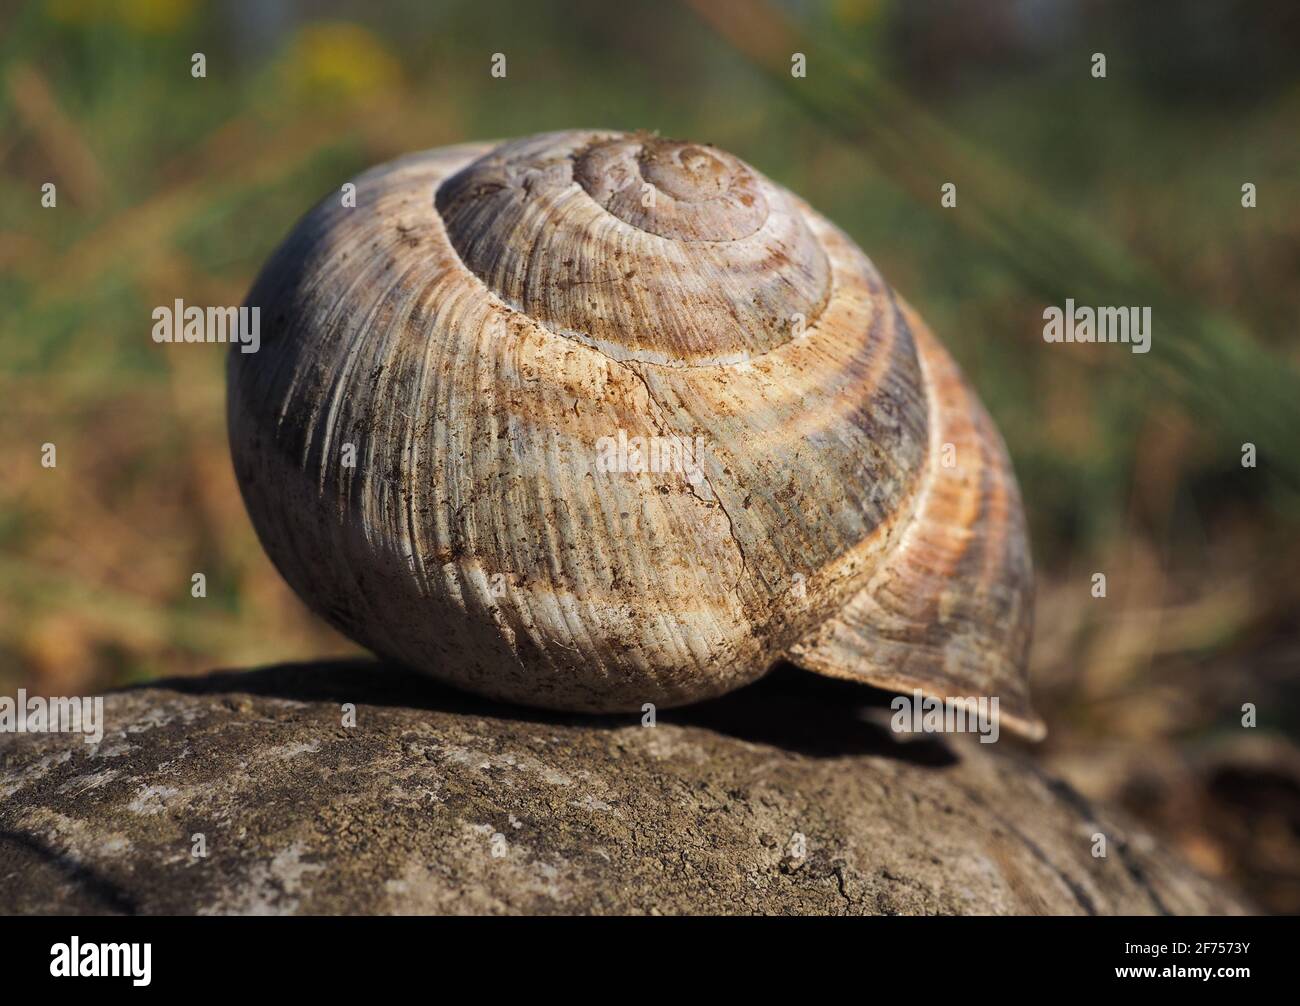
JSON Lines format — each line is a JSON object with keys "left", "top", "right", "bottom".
{"left": 229, "top": 131, "right": 1043, "bottom": 736}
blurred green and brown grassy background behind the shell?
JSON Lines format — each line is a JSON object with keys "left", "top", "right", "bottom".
{"left": 0, "top": 0, "right": 1300, "bottom": 911}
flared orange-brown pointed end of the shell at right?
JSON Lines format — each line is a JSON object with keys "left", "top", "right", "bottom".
{"left": 789, "top": 307, "right": 1044, "bottom": 740}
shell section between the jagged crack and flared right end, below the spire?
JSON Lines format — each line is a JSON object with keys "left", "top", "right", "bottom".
{"left": 621, "top": 222, "right": 928, "bottom": 655}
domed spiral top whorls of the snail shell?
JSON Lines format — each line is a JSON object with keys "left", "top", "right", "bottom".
{"left": 434, "top": 131, "right": 832, "bottom": 367}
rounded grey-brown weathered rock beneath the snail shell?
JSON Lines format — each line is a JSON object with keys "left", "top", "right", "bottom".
{"left": 0, "top": 662, "right": 1245, "bottom": 914}
